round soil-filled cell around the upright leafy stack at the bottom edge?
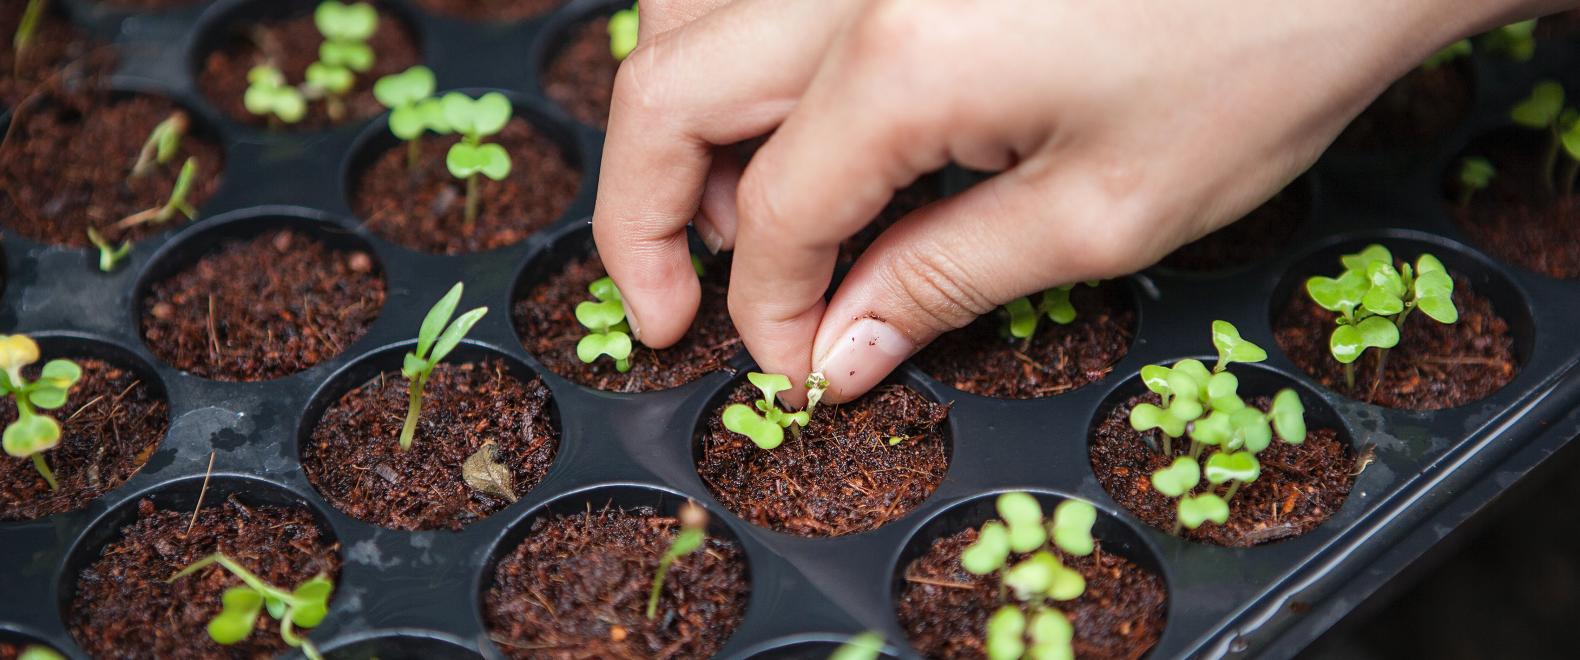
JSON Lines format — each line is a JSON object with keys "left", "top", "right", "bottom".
{"left": 890, "top": 491, "right": 1169, "bottom": 658}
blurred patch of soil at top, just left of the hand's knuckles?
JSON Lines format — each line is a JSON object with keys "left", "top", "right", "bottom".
{"left": 544, "top": 16, "right": 619, "bottom": 128}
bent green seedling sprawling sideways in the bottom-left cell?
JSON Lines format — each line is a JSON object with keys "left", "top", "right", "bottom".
{"left": 167, "top": 553, "right": 335, "bottom": 660}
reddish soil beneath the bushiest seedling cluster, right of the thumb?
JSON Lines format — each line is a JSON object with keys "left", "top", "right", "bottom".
{"left": 1092, "top": 393, "right": 1357, "bottom": 548}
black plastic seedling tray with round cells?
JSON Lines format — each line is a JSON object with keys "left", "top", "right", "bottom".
{"left": 0, "top": 0, "right": 1580, "bottom": 658}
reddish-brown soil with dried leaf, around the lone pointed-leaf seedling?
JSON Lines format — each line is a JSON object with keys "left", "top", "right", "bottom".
{"left": 302, "top": 360, "right": 559, "bottom": 529}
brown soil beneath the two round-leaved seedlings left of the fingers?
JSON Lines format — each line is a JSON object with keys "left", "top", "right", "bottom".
{"left": 356, "top": 118, "right": 581, "bottom": 254}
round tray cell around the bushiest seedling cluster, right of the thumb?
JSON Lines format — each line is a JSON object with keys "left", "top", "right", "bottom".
{"left": 1087, "top": 357, "right": 1357, "bottom": 546}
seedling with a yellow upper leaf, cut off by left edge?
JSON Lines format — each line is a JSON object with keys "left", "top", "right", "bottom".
{"left": 0, "top": 335, "right": 82, "bottom": 489}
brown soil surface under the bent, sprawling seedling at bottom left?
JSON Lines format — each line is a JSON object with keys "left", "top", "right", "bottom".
{"left": 66, "top": 493, "right": 340, "bottom": 660}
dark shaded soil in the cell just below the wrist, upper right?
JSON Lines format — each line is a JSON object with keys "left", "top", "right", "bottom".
{"left": 1335, "top": 57, "right": 1474, "bottom": 152}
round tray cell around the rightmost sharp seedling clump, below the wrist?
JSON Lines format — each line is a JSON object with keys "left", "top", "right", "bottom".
{"left": 1269, "top": 232, "right": 1534, "bottom": 411}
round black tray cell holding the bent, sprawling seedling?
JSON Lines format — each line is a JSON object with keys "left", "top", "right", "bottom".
{"left": 58, "top": 474, "right": 346, "bottom": 658}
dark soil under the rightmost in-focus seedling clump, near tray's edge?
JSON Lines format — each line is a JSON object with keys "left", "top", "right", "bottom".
{"left": 1273, "top": 279, "right": 1520, "bottom": 411}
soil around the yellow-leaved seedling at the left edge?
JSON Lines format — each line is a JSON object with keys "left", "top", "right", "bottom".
{"left": 0, "top": 355, "right": 169, "bottom": 519}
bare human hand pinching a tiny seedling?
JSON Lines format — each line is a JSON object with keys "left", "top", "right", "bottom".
{"left": 593, "top": 0, "right": 1575, "bottom": 403}
